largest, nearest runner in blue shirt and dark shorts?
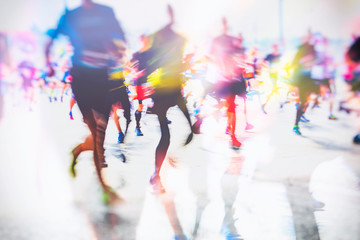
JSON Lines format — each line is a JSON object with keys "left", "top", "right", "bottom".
{"left": 46, "top": 0, "right": 125, "bottom": 200}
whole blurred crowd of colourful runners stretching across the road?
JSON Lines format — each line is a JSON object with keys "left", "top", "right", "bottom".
{"left": 0, "top": 0, "right": 360, "bottom": 233}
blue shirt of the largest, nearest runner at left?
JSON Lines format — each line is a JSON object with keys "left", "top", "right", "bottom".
{"left": 53, "top": 3, "right": 125, "bottom": 68}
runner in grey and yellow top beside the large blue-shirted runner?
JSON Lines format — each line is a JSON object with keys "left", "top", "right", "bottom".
{"left": 146, "top": 6, "right": 193, "bottom": 193}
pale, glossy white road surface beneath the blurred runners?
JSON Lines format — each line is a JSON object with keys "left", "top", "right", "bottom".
{"left": 0, "top": 86, "right": 360, "bottom": 240}
